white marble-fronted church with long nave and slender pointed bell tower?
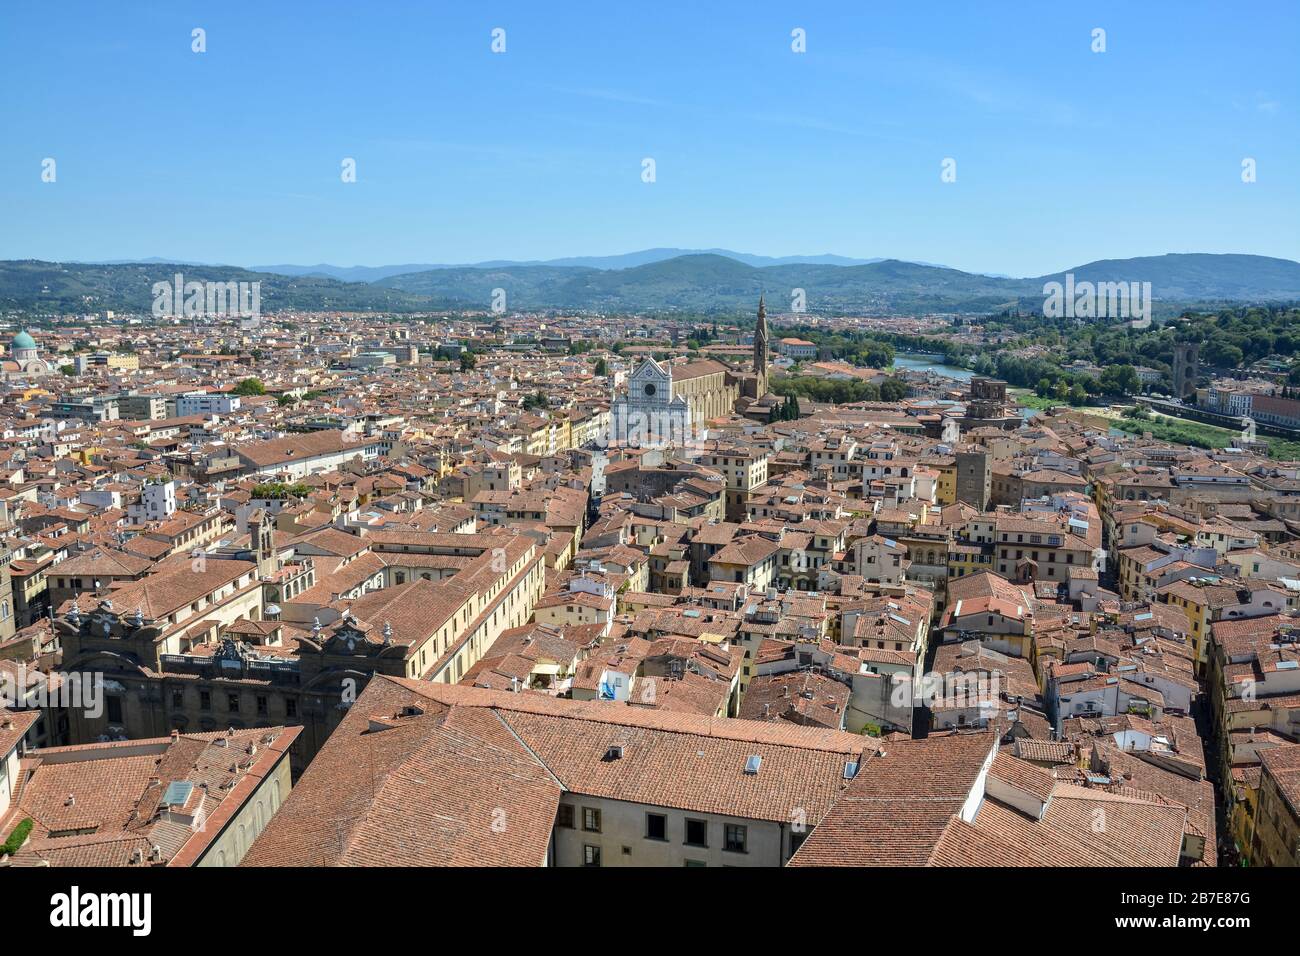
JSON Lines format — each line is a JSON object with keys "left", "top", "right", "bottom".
{"left": 610, "top": 299, "right": 767, "bottom": 447}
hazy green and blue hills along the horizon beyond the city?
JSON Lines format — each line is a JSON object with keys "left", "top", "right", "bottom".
{"left": 0, "top": 250, "right": 1300, "bottom": 315}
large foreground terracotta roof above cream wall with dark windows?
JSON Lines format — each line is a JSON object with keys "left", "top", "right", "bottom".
{"left": 244, "top": 676, "right": 872, "bottom": 865}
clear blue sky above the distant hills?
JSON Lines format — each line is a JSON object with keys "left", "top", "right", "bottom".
{"left": 0, "top": 0, "right": 1300, "bottom": 276}
